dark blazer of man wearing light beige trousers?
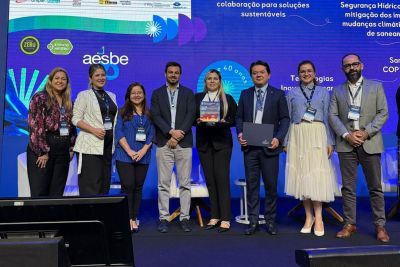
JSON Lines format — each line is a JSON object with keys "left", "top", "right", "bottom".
{"left": 150, "top": 85, "right": 196, "bottom": 147}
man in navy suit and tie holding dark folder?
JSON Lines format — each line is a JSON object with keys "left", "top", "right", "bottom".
{"left": 236, "top": 61, "right": 290, "bottom": 235}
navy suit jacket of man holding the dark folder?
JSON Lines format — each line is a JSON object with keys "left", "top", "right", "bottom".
{"left": 236, "top": 85, "right": 290, "bottom": 155}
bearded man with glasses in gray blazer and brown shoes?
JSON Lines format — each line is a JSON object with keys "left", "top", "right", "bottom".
{"left": 329, "top": 54, "right": 389, "bottom": 242}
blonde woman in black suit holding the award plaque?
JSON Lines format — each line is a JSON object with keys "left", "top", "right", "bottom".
{"left": 195, "top": 69, "right": 237, "bottom": 232}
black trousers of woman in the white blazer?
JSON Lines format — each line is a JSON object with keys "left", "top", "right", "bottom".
{"left": 78, "top": 131, "right": 113, "bottom": 196}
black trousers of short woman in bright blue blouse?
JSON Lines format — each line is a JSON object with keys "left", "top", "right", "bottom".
{"left": 116, "top": 160, "right": 149, "bottom": 220}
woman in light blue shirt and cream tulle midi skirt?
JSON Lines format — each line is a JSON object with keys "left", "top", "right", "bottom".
{"left": 284, "top": 60, "right": 338, "bottom": 236}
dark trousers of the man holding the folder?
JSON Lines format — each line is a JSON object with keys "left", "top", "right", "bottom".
{"left": 244, "top": 147, "right": 279, "bottom": 224}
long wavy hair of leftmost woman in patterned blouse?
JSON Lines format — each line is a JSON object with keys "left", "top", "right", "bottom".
{"left": 45, "top": 67, "right": 72, "bottom": 113}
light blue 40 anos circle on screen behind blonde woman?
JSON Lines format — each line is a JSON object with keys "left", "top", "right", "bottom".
{"left": 197, "top": 60, "right": 253, "bottom": 102}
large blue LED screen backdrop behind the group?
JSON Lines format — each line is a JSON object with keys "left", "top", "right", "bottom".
{"left": 4, "top": 0, "right": 400, "bottom": 197}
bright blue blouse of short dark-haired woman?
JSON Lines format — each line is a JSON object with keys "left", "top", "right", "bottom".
{"left": 114, "top": 114, "right": 154, "bottom": 164}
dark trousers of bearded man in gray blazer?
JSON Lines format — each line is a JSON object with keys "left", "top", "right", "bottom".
{"left": 338, "top": 146, "right": 386, "bottom": 226}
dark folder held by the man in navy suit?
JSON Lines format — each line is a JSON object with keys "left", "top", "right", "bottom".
{"left": 243, "top": 122, "right": 274, "bottom": 147}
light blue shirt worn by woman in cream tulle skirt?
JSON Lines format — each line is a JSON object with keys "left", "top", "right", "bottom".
{"left": 284, "top": 86, "right": 334, "bottom": 146}
